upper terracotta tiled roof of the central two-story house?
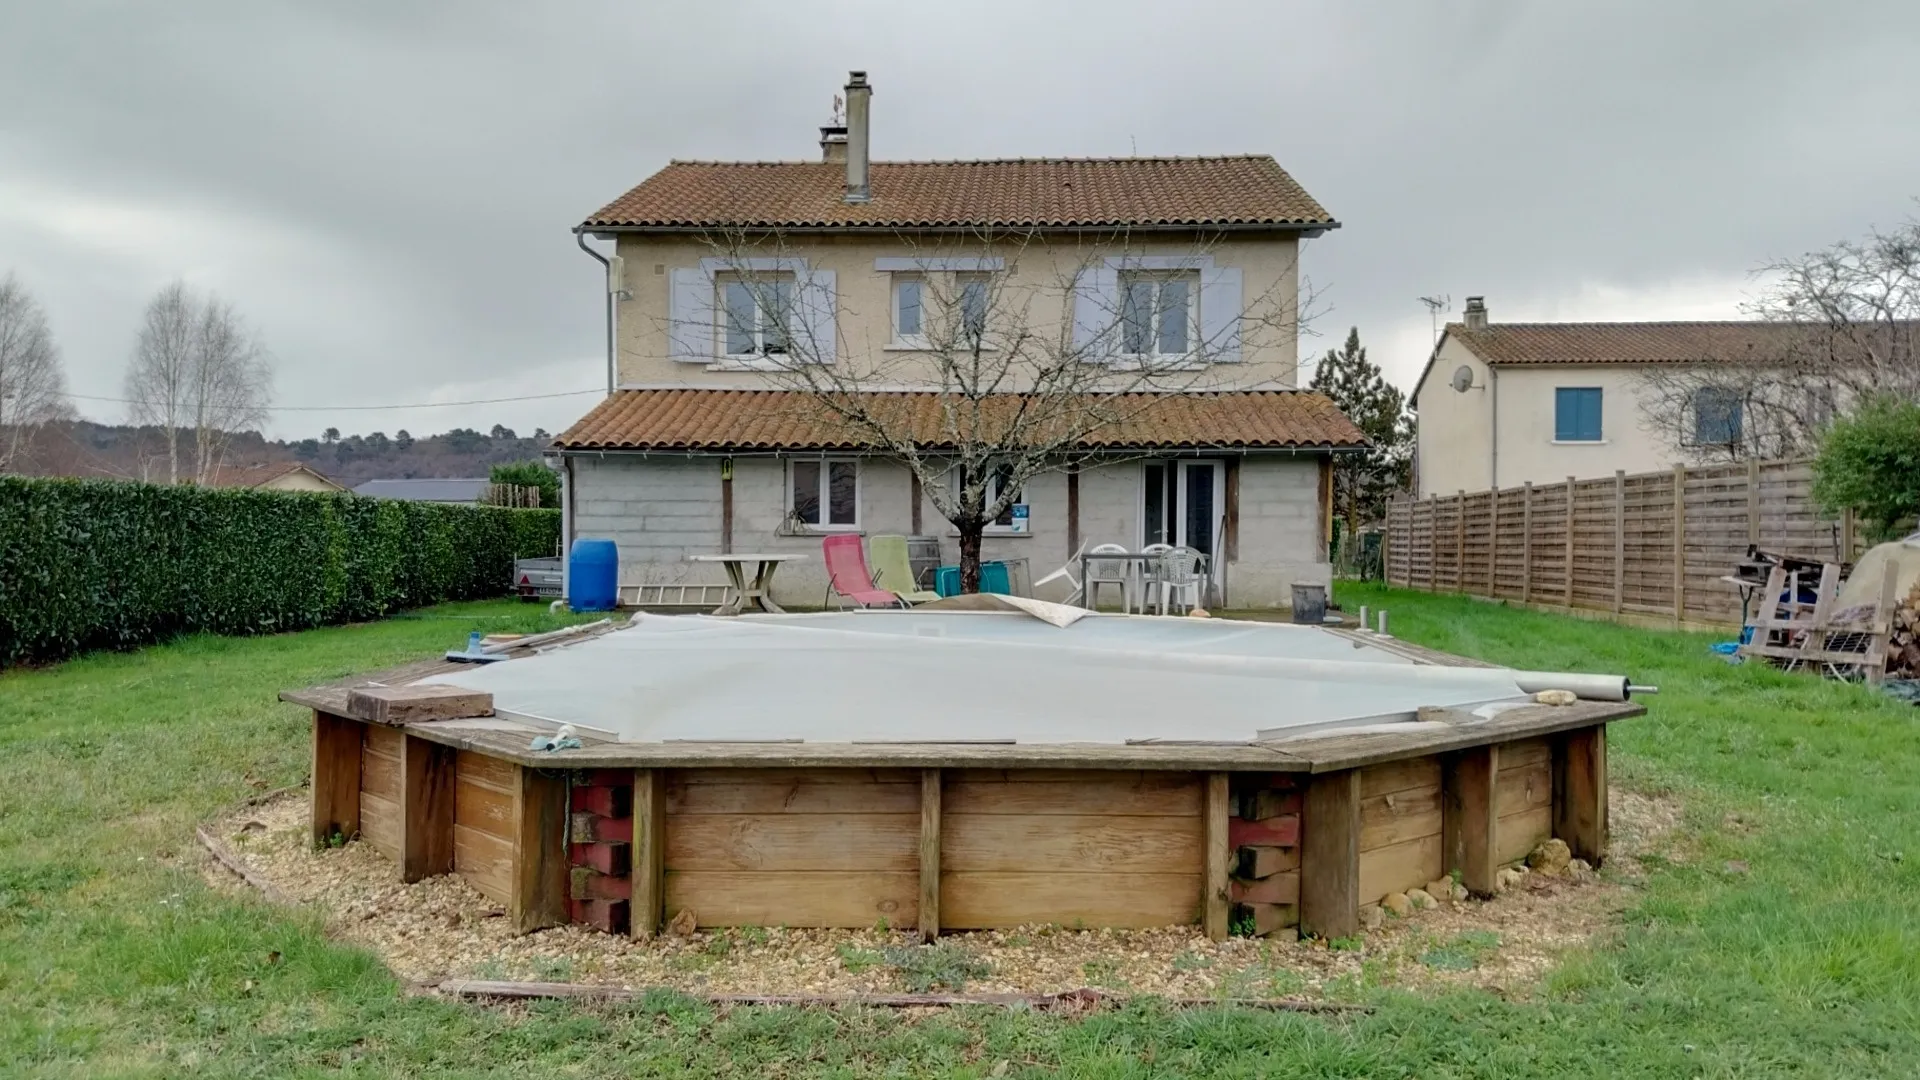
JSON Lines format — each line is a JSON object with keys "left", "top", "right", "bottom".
{"left": 584, "top": 154, "right": 1338, "bottom": 229}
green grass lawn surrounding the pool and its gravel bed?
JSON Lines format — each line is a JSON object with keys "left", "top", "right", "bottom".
{"left": 0, "top": 586, "right": 1920, "bottom": 1080}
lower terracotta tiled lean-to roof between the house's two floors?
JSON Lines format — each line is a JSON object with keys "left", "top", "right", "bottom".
{"left": 555, "top": 390, "right": 1367, "bottom": 452}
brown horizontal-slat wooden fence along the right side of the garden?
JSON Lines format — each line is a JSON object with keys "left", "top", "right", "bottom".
{"left": 1386, "top": 461, "right": 1859, "bottom": 625}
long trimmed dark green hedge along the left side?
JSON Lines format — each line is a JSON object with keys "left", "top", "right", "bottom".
{"left": 0, "top": 477, "right": 561, "bottom": 665}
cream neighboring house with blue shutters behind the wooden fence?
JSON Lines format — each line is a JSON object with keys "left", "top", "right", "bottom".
{"left": 1409, "top": 296, "right": 1805, "bottom": 498}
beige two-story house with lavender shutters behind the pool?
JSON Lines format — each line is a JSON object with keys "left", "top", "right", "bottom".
{"left": 555, "top": 73, "right": 1365, "bottom": 605}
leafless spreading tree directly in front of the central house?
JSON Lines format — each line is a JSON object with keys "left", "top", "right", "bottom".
{"left": 687, "top": 231, "right": 1311, "bottom": 592}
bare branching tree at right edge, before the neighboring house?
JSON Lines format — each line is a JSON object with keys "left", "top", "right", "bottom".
{"left": 1640, "top": 221, "right": 1920, "bottom": 461}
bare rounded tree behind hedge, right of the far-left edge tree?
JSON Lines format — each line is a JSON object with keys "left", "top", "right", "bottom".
{"left": 127, "top": 281, "right": 273, "bottom": 484}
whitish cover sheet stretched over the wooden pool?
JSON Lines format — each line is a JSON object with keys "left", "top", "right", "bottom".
{"left": 416, "top": 611, "right": 1574, "bottom": 744}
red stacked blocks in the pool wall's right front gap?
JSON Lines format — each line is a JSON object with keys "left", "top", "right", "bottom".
{"left": 1227, "top": 773, "right": 1300, "bottom": 936}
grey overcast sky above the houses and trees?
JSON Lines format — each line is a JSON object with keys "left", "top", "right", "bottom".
{"left": 0, "top": 0, "right": 1920, "bottom": 438}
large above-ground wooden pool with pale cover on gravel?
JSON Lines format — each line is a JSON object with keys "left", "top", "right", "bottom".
{"left": 282, "top": 611, "right": 1642, "bottom": 938}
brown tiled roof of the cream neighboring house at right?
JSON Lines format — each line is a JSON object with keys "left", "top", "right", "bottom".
{"left": 1446, "top": 321, "right": 1809, "bottom": 363}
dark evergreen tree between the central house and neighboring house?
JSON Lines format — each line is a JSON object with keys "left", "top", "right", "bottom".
{"left": 1309, "top": 327, "right": 1413, "bottom": 536}
